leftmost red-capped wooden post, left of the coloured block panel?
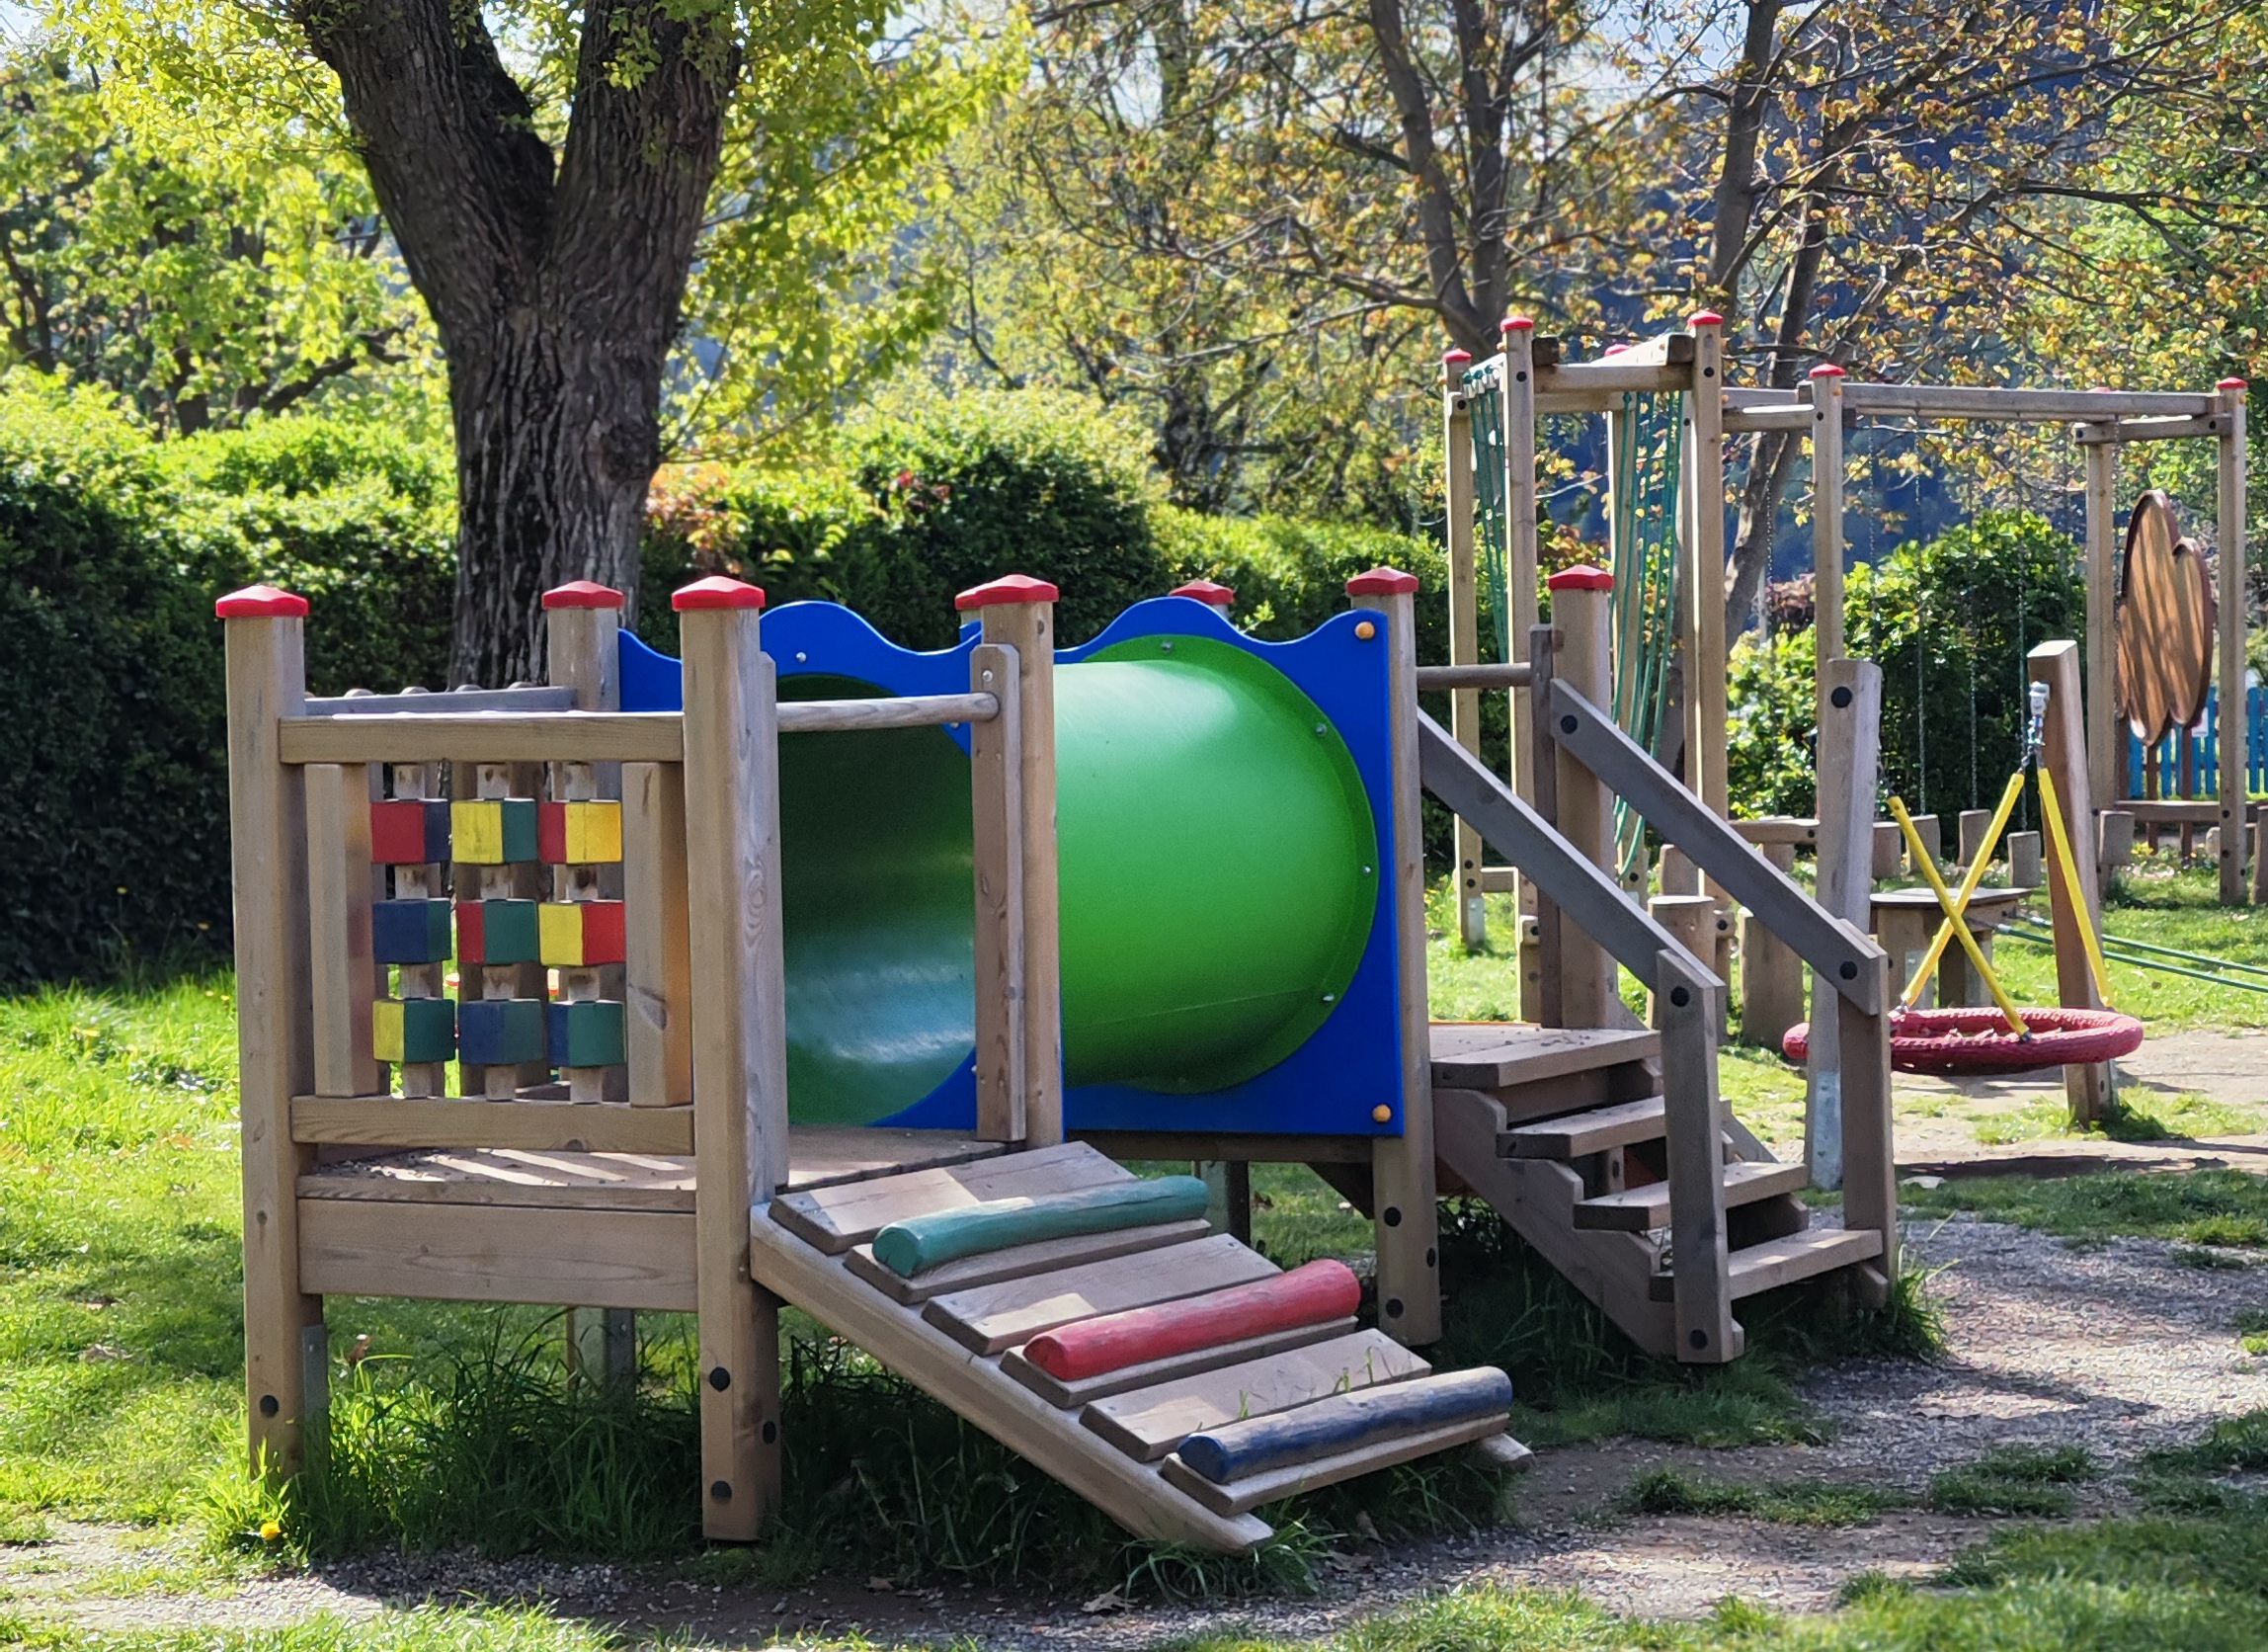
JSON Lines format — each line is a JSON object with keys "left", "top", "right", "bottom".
{"left": 213, "top": 586, "right": 324, "bottom": 1475}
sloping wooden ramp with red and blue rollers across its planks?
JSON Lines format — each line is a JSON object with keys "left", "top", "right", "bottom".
{"left": 749, "top": 1144, "right": 1526, "bottom": 1552}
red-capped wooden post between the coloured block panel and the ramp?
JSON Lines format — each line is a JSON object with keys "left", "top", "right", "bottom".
{"left": 672, "top": 576, "right": 787, "bottom": 1543}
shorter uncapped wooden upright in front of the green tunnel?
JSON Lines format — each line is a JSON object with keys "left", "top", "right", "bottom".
{"left": 968, "top": 642, "right": 1027, "bottom": 1141}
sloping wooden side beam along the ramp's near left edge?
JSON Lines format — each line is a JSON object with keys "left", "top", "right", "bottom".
{"left": 749, "top": 1221, "right": 1270, "bottom": 1554}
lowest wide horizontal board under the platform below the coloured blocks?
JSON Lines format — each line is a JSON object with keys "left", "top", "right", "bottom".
{"left": 297, "top": 1198, "right": 696, "bottom": 1311}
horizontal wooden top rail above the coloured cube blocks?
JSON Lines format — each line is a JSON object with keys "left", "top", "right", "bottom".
{"left": 282, "top": 710, "right": 685, "bottom": 763}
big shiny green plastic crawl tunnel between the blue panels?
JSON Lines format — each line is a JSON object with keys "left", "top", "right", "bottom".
{"left": 780, "top": 635, "right": 1377, "bottom": 1123}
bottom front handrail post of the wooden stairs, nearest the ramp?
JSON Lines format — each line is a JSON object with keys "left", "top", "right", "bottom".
{"left": 1654, "top": 949, "right": 1742, "bottom": 1362}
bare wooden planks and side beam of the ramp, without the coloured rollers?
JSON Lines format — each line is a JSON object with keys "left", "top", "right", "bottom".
{"left": 749, "top": 1141, "right": 1522, "bottom": 1552}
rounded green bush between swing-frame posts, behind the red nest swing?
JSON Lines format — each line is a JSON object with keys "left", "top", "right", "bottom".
{"left": 1846, "top": 511, "right": 2084, "bottom": 815}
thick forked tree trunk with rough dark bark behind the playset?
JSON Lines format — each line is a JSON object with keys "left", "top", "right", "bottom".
{"left": 297, "top": 0, "right": 739, "bottom": 686}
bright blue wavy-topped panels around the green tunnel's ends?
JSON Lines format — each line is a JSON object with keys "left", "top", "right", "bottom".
{"left": 621, "top": 597, "right": 1404, "bottom": 1137}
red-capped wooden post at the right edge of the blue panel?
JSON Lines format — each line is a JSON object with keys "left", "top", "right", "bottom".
{"left": 1347, "top": 567, "right": 1440, "bottom": 1344}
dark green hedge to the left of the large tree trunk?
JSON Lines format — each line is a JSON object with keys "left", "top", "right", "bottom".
{"left": 0, "top": 370, "right": 451, "bottom": 980}
